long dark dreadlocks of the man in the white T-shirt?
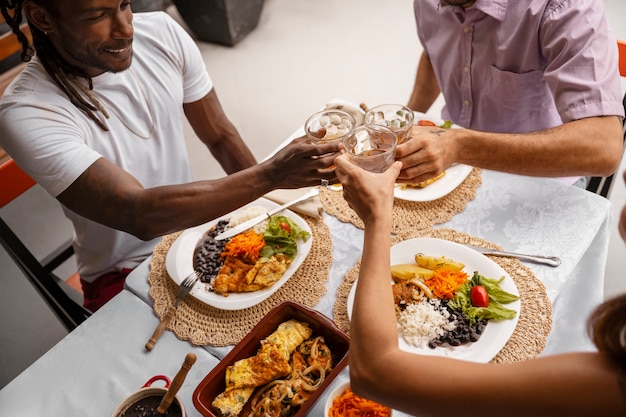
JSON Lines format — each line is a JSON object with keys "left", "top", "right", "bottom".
{"left": 0, "top": 0, "right": 109, "bottom": 131}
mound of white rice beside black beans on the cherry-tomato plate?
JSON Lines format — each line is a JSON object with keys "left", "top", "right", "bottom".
{"left": 398, "top": 298, "right": 456, "bottom": 348}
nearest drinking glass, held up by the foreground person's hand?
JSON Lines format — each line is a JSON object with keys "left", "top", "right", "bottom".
{"left": 343, "top": 125, "right": 398, "bottom": 173}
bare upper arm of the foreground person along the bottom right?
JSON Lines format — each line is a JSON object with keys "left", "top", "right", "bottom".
{"left": 351, "top": 352, "right": 626, "bottom": 417}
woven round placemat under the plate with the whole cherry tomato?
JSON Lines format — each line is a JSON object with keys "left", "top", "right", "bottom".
{"left": 333, "top": 229, "right": 552, "bottom": 363}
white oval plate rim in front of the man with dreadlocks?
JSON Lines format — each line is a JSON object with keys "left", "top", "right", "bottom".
{"left": 165, "top": 198, "right": 313, "bottom": 310}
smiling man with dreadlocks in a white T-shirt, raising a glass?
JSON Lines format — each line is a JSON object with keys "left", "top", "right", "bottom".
{"left": 0, "top": 0, "right": 338, "bottom": 311}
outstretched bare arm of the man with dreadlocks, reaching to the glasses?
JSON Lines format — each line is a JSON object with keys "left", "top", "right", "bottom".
{"left": 57, "top": 138, "right": 339, "bottom": 240}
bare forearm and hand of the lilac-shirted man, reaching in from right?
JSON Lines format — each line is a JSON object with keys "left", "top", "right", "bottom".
{"left": 396, "top": 116, "right": 623, "bottom": 182}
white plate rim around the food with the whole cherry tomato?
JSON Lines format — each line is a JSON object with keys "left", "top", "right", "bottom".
{"left": 347, "top": 238, "right": 521, "bottom": 363}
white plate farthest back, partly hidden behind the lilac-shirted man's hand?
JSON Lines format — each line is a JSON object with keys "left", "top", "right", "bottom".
{"left": 393, "top": 112, "right": 472, "bottom": 202}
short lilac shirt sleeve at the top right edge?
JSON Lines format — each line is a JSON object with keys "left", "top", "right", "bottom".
{"left": 540, "top": 0, "right": 624, "bottom": 122}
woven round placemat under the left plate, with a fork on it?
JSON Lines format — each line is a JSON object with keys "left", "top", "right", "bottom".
{"left": 148, "top": 216, "right": 333, "bottom": 346}
